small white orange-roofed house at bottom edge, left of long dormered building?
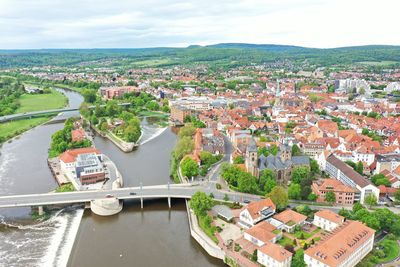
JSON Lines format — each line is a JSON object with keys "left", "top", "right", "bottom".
{"left": 257, "top": 242, "right": 292, "bottom": 267}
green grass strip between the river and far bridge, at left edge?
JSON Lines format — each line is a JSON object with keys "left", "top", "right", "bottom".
{"left": 0, "top": 117, "right": 49, "bottom": 141}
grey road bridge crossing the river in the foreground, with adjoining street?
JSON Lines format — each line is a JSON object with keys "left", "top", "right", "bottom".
{"left": 0, "top": 184, "right": 260, "bottom": 208}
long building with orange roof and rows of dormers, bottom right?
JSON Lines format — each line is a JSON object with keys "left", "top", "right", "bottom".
{"left": 304, "top": 221, "right": 375, "bottom": 267}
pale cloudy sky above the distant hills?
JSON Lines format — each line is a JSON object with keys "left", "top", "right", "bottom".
{"left": 0, "top": 0, "right": 400, "bottom": 49}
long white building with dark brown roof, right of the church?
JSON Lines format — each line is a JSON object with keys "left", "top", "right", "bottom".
{"left": 325, "top": 155, "right": 379, "bottom": 204}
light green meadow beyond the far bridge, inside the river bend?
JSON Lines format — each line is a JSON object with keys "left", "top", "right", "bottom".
{"left": 15, "top": 90, "right": 67, "bottom": 113}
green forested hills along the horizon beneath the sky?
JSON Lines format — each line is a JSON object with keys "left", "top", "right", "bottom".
{"left": 0, "top": 43, "right": 400, "bottom": 68}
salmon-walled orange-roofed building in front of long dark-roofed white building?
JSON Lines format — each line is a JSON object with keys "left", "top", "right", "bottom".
{"left": 311, "top": 179, "right": 358, "bottom": 205}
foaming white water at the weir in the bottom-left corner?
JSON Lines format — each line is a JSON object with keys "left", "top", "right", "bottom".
{"left": 0, "top": 209, "right": 83, "bottom": 267}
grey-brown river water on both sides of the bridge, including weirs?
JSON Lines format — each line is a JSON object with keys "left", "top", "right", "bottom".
{"left": 0, "top": 91, "right": 223, "bottom": 267}
